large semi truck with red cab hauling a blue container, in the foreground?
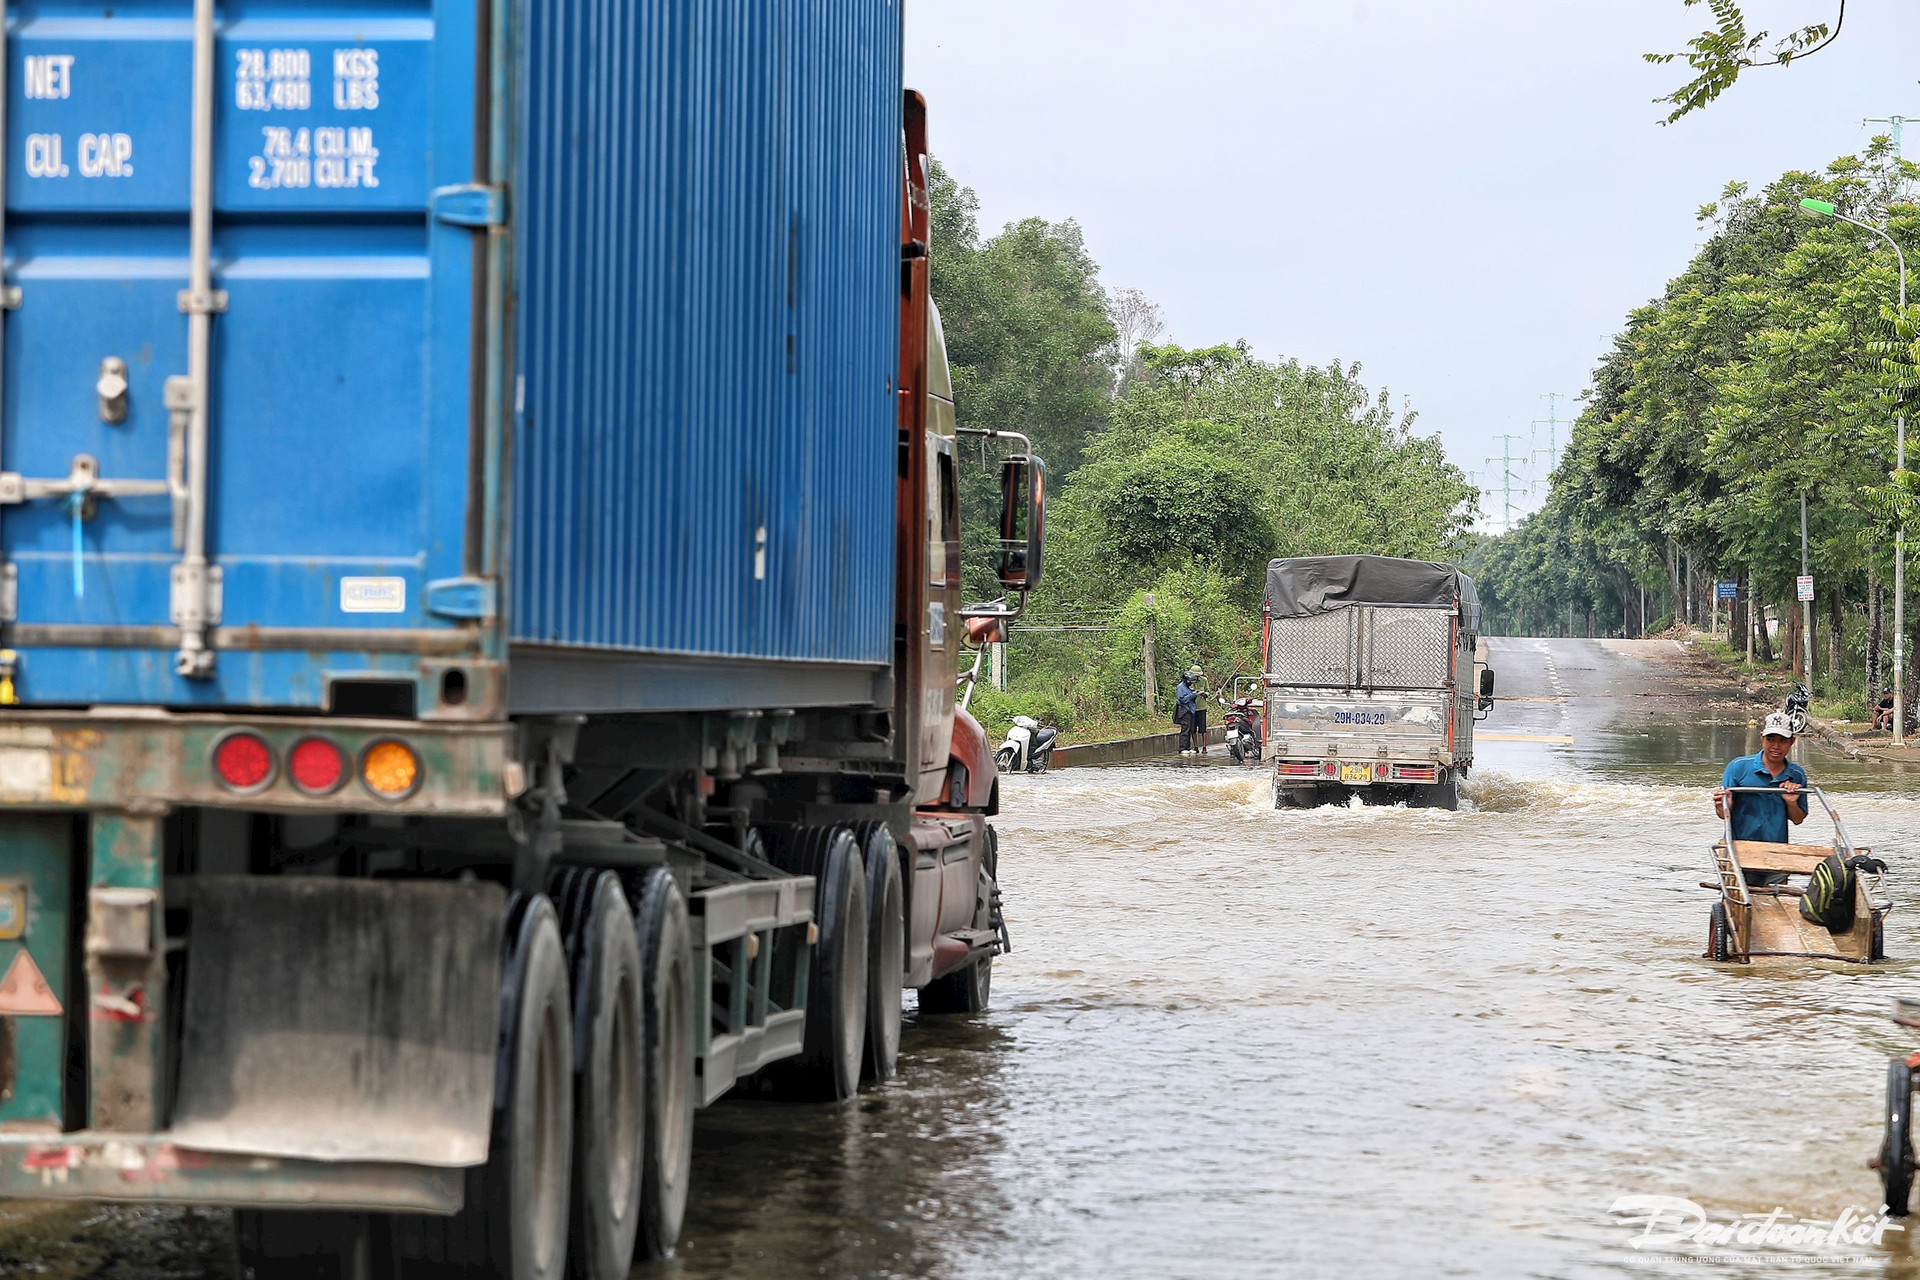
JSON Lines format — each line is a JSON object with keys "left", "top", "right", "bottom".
{"left": 0, "top": 0, "right": 1043, "bottom": 1280}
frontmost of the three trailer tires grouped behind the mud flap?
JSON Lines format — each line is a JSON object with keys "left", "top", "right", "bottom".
{"left": 634, "top": 867, "right": 695, "bottom": 1259}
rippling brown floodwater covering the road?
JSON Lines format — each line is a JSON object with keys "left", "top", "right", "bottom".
{"left": 3, "top": 641, "right": 1920, "bottom": 1280}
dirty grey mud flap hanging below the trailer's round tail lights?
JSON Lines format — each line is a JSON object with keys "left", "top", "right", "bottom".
{"left": 169, "top": 877, "right": 507, "bottom": 1167}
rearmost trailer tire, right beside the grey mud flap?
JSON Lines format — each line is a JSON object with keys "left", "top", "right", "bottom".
{"left": 396, "top": 894, "right": 574, "bottom": 1280}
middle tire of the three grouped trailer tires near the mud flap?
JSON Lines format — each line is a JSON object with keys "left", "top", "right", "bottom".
{"left": 557, "top": 871, "right": 647, "bottom": 1280}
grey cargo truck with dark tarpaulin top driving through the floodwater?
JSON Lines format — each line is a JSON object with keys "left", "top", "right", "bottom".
{"left": 1261, "top": 555, "right": 1494, "bottom": 810}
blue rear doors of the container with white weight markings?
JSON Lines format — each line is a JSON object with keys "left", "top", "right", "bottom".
{"left": 0, "top": 0, "right": 480, "bottom": 706}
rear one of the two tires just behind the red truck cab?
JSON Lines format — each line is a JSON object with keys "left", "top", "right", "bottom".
{"left": 768, "top": 827, "right": 868, "bottom": 1102}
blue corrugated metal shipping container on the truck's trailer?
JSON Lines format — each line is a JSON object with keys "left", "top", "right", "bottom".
{"left": 0, "top": 0, "right": 902, "bottom": 714}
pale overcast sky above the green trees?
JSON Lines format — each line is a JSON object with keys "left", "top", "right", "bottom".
{"left": 906, "top": 0, "right": 1920, "bottom": 528}
